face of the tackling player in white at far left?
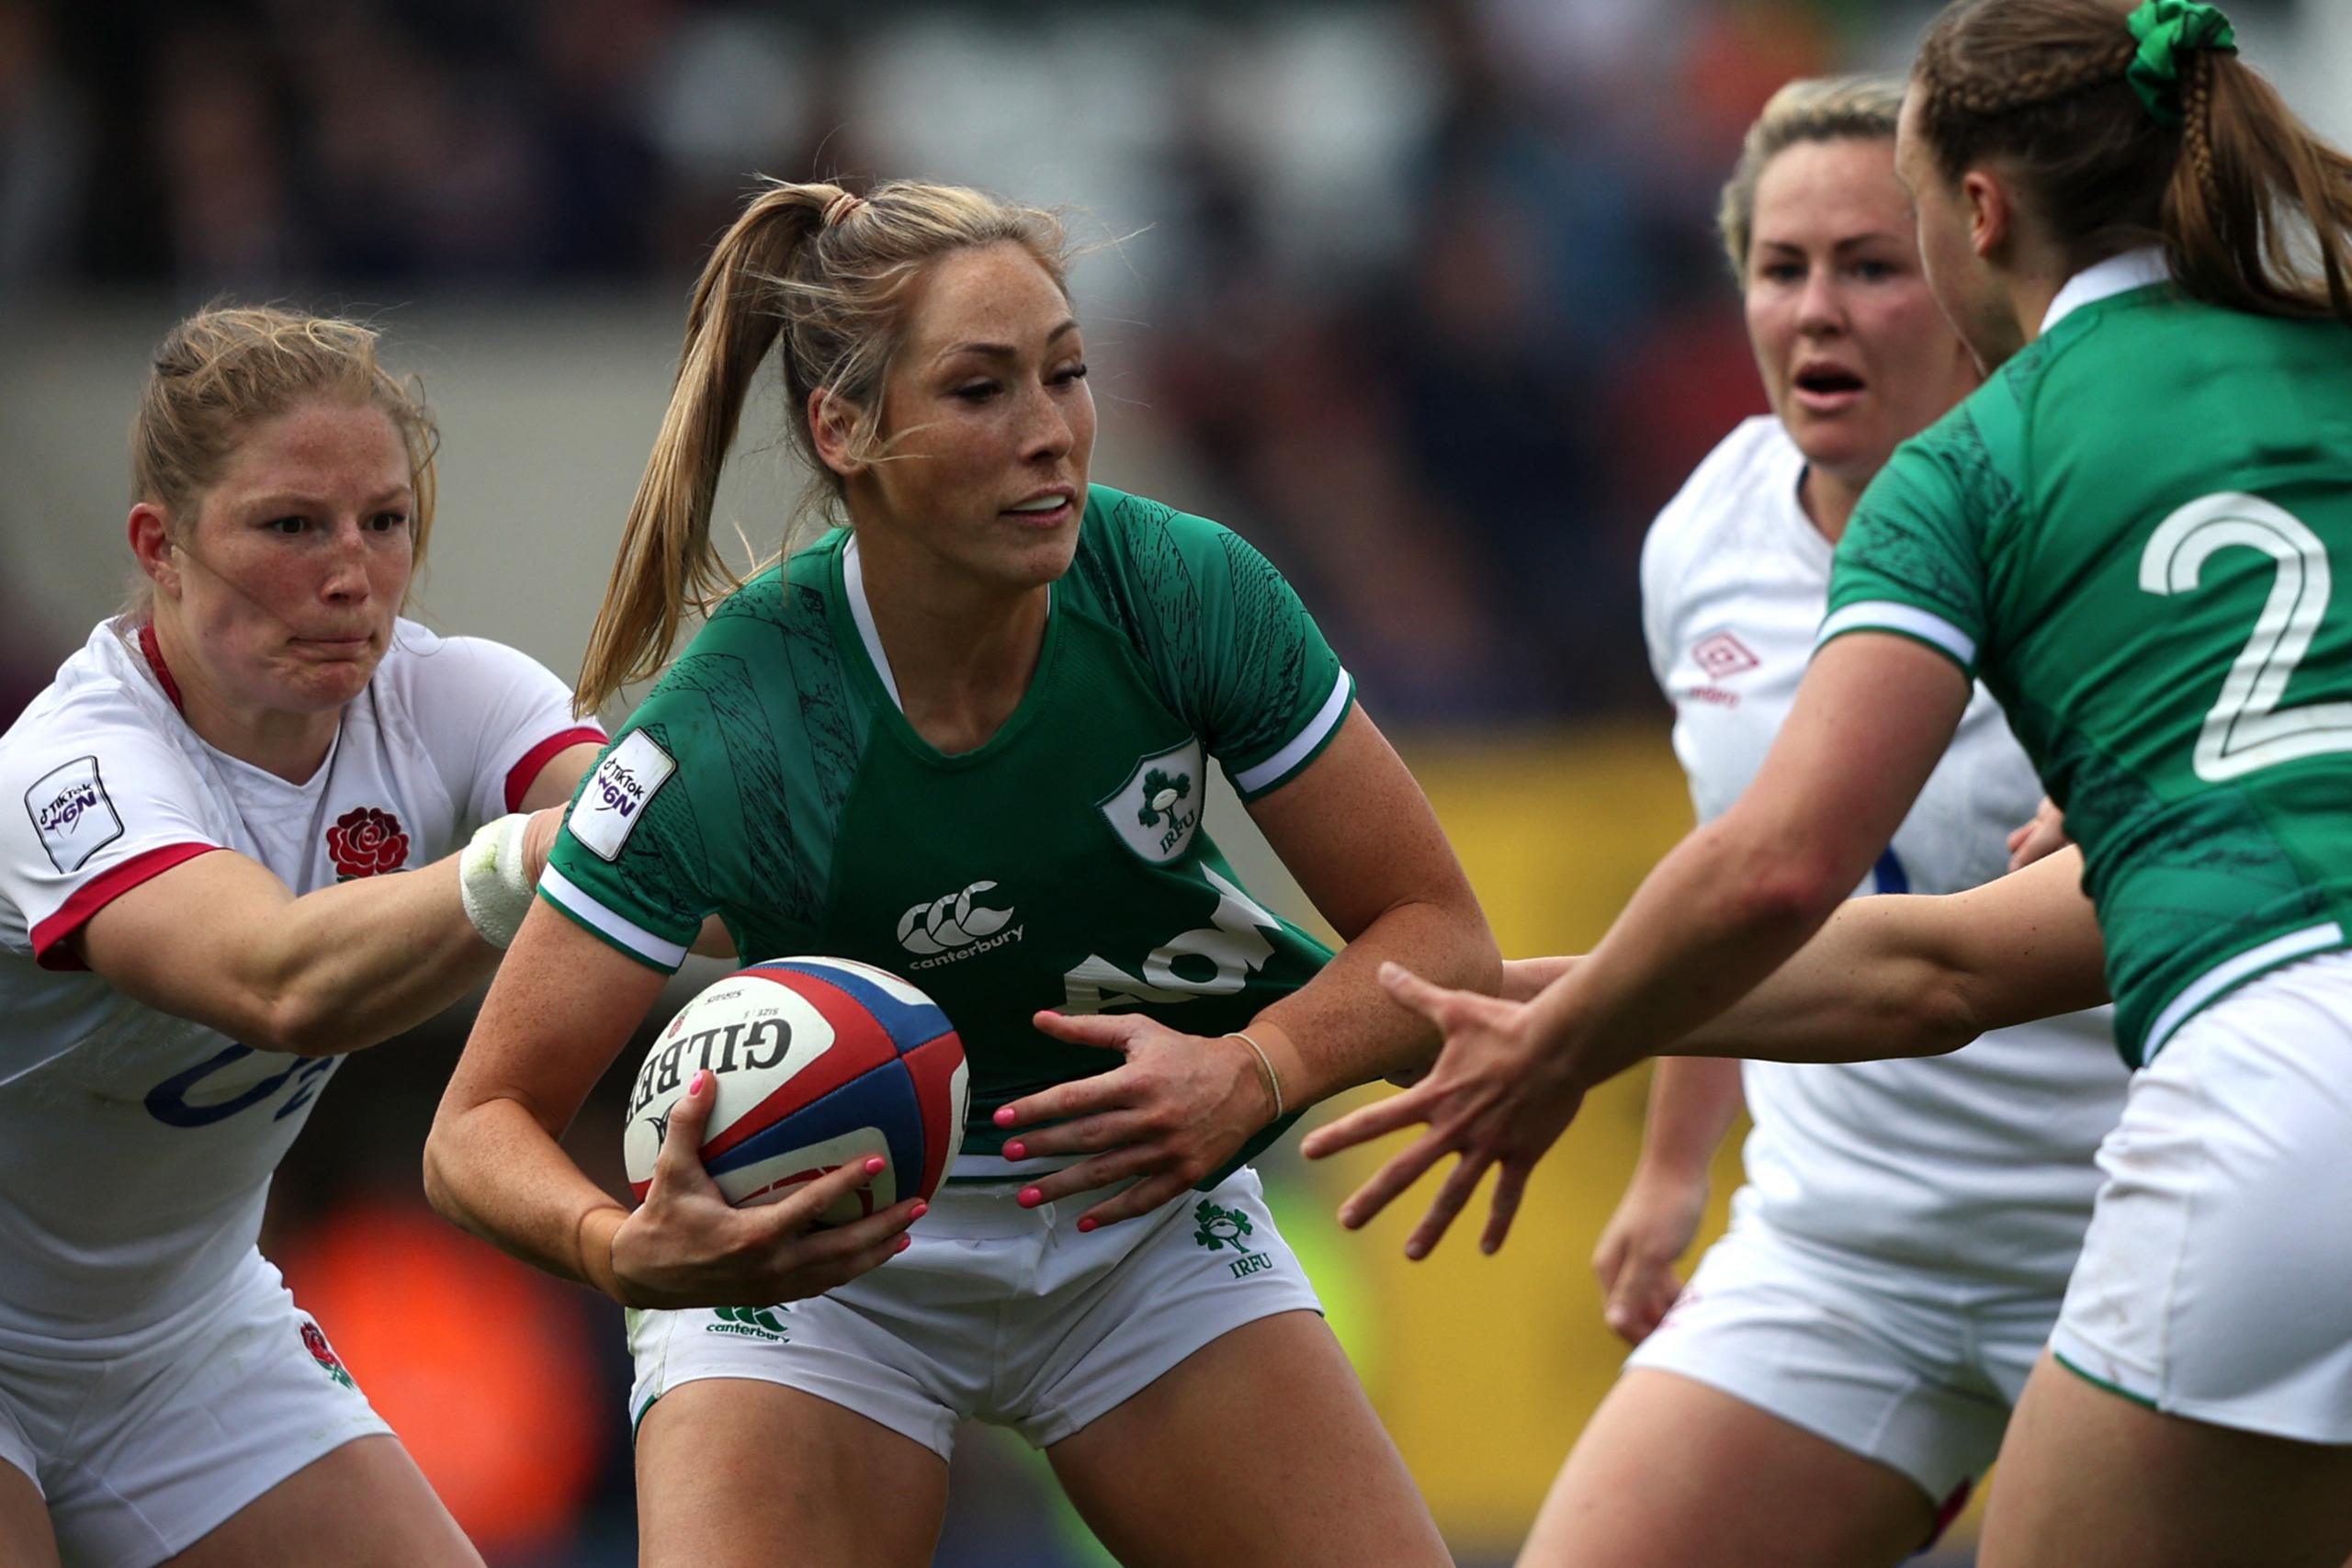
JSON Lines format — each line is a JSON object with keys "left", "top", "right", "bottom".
{"left": 155, "top": 400, "right": 416, "bottom": 712}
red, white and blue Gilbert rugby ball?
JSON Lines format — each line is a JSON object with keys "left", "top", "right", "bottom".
{"left": 623, "top": 959, "right": 967, "bottom": 1224}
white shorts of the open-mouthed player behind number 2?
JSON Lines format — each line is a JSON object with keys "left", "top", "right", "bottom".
{"left": 1625, "top": 1220, "right": 2058, "bottom": 1506}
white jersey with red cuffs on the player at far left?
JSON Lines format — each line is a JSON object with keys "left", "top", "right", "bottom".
{"left": 0, "top": 621, "right": 605, "bottom": 1349}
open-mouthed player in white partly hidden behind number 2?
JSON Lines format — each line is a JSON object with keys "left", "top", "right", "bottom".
{"left": 1512, "top": 77, "right": 2124, "bottom": 1568}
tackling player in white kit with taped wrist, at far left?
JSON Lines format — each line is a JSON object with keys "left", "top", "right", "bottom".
{"left": 0, "top": 308, "right": 625, "bottom": 1568}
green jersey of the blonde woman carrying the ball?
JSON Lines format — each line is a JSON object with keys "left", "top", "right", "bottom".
{"left": 538, "top": 487, "right": 1355, "bottom": 1159}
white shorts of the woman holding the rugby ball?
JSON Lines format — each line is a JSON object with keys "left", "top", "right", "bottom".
{"left": 628, "top": 1156, "right": 1322, "bottom": 1458}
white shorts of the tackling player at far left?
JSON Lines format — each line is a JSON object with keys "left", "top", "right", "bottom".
{"left": 0, "top": 1253, "right": 390, "bottom": 1568}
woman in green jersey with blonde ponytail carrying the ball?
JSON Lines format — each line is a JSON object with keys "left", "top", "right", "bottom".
{"left": 428, "top": 181, "right": 1500, "bottom": 1568}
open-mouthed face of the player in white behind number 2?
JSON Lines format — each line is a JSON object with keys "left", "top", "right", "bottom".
{"left": 1746, "top": 136, "right": 1975, "bottom": 484}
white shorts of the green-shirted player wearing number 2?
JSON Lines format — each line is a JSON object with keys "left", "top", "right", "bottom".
{"left": 2051, "top": 952, "right": 2352, "bottom": 1443}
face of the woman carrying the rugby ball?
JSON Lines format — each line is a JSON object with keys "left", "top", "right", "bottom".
{"left": 852, "top": 243, "right": 1093, "bottom": 588}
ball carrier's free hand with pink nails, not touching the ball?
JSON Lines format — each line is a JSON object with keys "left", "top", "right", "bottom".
{"left": 995, "top": 1013, "right": 1275, "bottom": 1229}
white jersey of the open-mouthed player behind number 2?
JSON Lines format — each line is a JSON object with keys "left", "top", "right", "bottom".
{"left": 1642, "top": 416, "right": 2126, "bottom": 1291}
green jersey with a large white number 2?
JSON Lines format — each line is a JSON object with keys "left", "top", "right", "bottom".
{"left": 1820, "top": 252, "right": 2352, "bottom": 1065}
